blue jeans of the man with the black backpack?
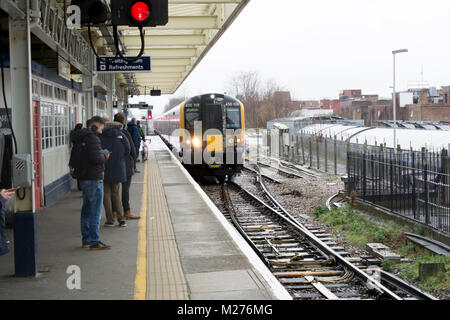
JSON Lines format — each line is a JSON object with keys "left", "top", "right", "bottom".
{"left": 80, "top": 180, "right": 103, "bottom": 245}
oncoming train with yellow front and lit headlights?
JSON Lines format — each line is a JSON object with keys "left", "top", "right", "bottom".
{"left": 154, "top": 94, "right": 245, "bottom": 181}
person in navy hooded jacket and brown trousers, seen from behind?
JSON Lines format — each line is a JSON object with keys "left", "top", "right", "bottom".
{"left": 100, "top": 122, "right": 130, "bottom": 227}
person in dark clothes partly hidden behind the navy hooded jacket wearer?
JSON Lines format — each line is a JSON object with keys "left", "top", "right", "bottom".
{"left": 114, "top": 112, "right": 141, "bottom": 219}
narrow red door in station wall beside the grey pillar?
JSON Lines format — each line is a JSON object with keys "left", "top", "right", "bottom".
{"left": 33, "top": 100, "right": 42, "bottom": 209}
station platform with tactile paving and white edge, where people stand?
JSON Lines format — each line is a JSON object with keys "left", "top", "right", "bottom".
{"left": 0, "top": 137, "right": 289, "bottom": 300}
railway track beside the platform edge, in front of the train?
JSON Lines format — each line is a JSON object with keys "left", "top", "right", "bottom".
{"left": 203, "top": 166, "right": 434, "bottom": 300}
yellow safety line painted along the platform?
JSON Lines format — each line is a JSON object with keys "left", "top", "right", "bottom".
{"left": 134, "top": 161, "right": 148, "bottom": 300}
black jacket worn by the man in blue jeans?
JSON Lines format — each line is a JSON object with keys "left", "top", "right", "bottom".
{"left": 71, "top": 128, "right": 106, "bottom": 180}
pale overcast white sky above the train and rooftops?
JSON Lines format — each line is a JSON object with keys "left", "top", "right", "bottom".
{"left": 132, "top": 0, "right": 450, "bottom": 113}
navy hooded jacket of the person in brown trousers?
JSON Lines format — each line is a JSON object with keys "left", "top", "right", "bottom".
{"left": 100, "top": 122, "right": 130, "bottom": 183}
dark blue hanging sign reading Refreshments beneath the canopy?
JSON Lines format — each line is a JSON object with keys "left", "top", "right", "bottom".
{"left": 97, "top": 56, "right": 152, "bottom": 73}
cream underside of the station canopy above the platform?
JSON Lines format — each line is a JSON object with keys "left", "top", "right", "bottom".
{"left": 92, "top": 0, "right": 250, "bottom": 94}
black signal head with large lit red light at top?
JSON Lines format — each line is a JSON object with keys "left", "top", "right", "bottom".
{"left": 111, "top": 0, "right": 169, "bottom": 27}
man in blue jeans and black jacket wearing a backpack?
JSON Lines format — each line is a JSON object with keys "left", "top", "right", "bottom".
{"left": 69, "top": 116, "right": 111, "bottom": 250}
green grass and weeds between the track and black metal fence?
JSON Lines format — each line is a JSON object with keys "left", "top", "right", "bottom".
{"left": 312, "top": 206, "right": 450, "bottom": 299}
